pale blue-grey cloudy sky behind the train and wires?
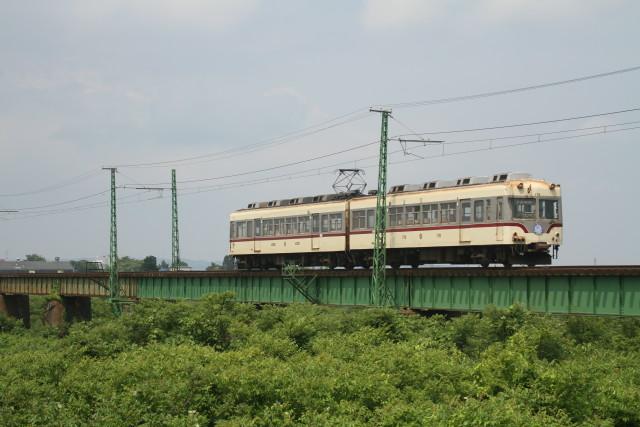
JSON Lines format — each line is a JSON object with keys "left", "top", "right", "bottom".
{"left": 0, "top": 0, "right": 640, "bottom": 264}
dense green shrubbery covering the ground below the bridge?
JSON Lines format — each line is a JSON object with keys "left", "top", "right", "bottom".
{"left": 0, "top": 300, "right": 640, "bottom": 426}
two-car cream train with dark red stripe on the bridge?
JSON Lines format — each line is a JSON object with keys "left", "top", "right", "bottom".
{"left": 229, "top": 173, "right": 562, "bottom": 268}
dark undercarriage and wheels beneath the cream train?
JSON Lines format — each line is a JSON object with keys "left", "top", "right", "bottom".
{"left": 236, "top": 245, "right": 557, "bottom": 269}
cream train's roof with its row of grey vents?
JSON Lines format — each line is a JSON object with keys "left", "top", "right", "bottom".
{"left": 241, "top": 172, "right": 532, "bottom": 210}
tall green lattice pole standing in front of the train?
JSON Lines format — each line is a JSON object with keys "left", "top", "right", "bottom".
{"left": 369, "top": 108, "right": 393, "bottom": 306}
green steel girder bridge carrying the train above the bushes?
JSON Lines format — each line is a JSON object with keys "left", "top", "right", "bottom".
{"left": 0, "top": 266, "right": 640, "bottom": 324}
